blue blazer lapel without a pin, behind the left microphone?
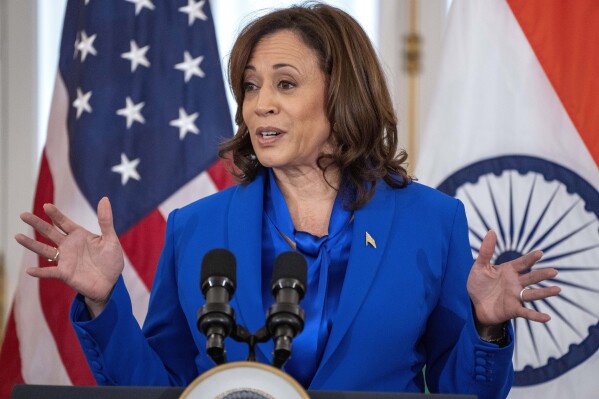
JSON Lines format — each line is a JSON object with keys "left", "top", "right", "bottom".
{"left": 227, "top": 173, "right": 265, "bottom": 340}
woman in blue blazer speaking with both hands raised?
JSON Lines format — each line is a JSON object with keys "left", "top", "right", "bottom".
{"left": 17, "top": 4, "right": 559, "bottom": 398}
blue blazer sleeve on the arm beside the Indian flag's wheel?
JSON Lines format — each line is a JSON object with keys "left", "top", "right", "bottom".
{"left": 425, "top": 201, "right": 514, "bottom": 399}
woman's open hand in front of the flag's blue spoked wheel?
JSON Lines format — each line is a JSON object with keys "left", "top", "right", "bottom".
{"left": 467, "top": 231, "right": 561, "bottom": 326}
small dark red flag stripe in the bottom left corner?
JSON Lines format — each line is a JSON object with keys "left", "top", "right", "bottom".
{"left": 0, "top": 306, "right": 25, "bottom": 399}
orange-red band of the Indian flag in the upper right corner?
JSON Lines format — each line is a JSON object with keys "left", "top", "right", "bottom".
{"left": 508, "top": 0, "right": 599, "bottom": 166}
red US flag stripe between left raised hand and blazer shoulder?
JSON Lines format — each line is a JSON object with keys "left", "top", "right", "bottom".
{"left": 119, "top": 209, "right": 166, "bottom": 290}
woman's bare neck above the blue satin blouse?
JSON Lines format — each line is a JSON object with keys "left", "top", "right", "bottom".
{"left": 273, "top": 167, "right": 340, "bottom": 237}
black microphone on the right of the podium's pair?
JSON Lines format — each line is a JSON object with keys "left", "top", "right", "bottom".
{"left": 266, "top": 252, "right": 308, "bottom": 368}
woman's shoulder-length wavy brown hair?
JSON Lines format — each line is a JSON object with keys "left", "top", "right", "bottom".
{"left": 219, "top": 2, "right": 411, "bottom": 209}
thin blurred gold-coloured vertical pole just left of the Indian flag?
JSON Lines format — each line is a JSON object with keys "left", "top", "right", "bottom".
{"left": 403, "top": 0, "right": 421, "bottom": 174}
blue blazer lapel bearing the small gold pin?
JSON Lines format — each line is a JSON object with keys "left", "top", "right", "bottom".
{"left": 313, "top": 181, "right": 395, "bottom": 383}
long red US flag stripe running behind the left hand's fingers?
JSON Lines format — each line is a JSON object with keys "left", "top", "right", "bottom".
{"left": 33, "top": 152, "right": 95, "bottom": 385}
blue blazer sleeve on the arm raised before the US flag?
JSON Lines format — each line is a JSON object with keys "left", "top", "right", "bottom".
{"left": 70, "top": 211, "right": 197, "bottom": 386}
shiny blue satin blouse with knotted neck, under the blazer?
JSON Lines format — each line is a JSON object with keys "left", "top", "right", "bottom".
{"left": 262, "top": 170, "right": 353, "bottom": 387}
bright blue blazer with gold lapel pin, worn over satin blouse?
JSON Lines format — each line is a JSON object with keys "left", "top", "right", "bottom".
{"left": 71, "top": 173, "right": 513, "bottom": 399}
